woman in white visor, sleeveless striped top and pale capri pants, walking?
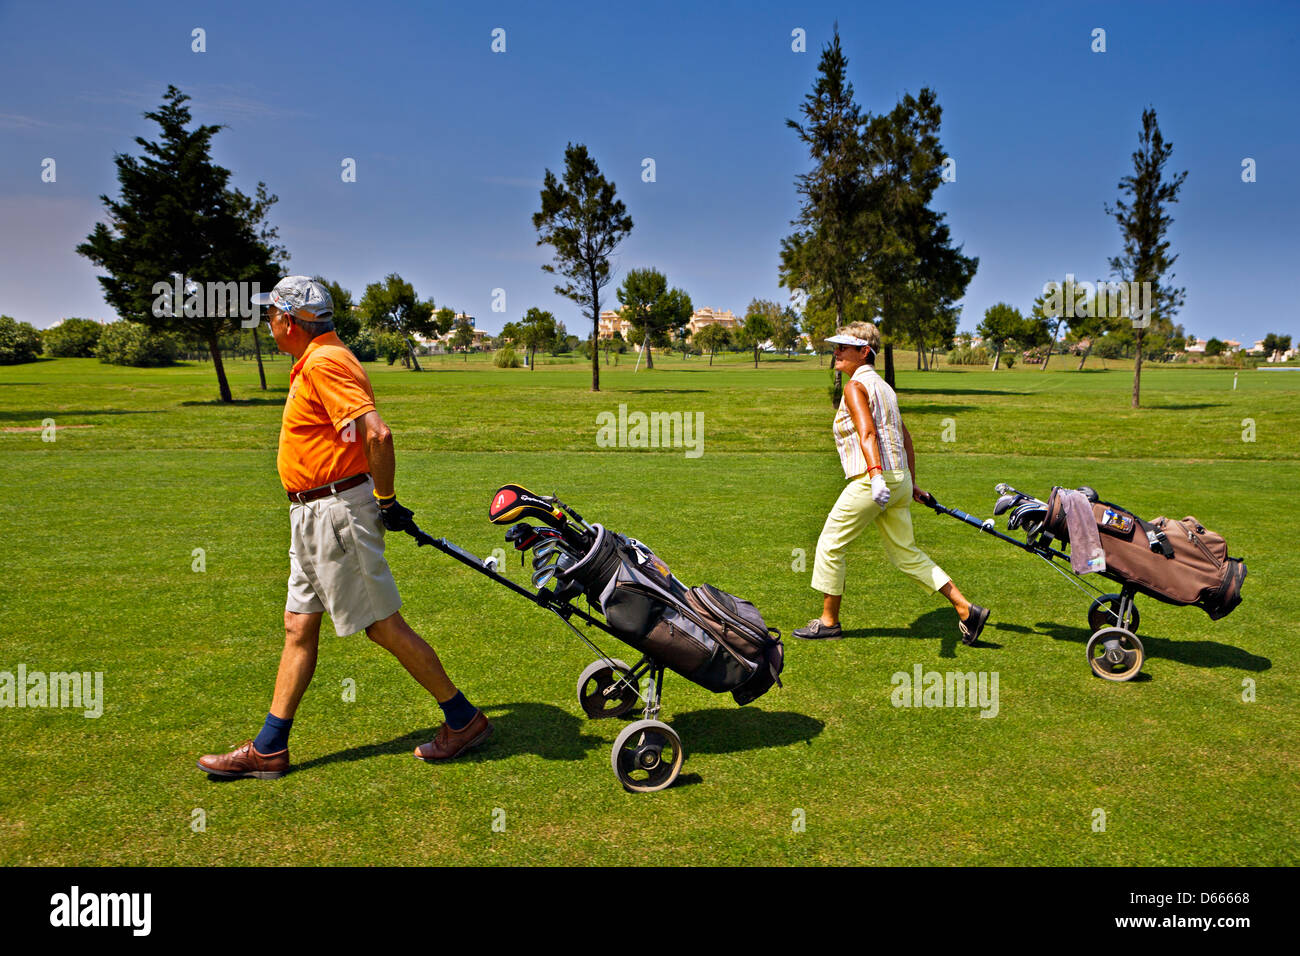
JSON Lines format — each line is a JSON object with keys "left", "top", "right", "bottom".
{"left": 794, "top": 323, "right": 988, "bottom": 644}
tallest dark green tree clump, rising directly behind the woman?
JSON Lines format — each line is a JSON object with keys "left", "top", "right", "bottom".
{"left": 780, "top": 27, "right": 979, "bottom": 401}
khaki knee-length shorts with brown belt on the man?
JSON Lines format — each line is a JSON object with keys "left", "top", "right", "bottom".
{"left": 285, "top": 481, "right": 402, "bottom": 635}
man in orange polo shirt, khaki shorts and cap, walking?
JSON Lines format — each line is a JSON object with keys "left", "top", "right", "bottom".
{"left": 199, "top": 276, "right": 493, "bottom": 779}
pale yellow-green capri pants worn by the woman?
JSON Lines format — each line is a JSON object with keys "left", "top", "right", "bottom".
{"left": 813, "top": 471, "right": 952, "bottom": 594}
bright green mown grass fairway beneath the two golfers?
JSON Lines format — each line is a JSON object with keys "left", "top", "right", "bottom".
{"left": 0, "top": 354, "right": 1300, "bottom": 866}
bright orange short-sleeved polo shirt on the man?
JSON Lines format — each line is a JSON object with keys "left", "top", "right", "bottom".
{"left": 276, "top": 332, "right": 374, "bottom": 493}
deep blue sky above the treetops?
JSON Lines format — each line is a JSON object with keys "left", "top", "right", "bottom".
{"left": 0, "top": 0, "right": 1300, "bottom": 341}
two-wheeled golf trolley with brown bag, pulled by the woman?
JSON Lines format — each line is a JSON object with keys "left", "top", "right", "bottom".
{"left": 922, "top": 484, "right": 1245, "bottom": 680}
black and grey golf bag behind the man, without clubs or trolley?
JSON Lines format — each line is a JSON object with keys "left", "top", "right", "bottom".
{"left": 555, "top": 524, "right": 785, "bottom": 704}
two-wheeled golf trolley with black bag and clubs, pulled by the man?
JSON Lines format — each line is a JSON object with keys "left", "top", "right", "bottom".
{"left": 411, "top": 485, "right": 783, "bottom": 792}
